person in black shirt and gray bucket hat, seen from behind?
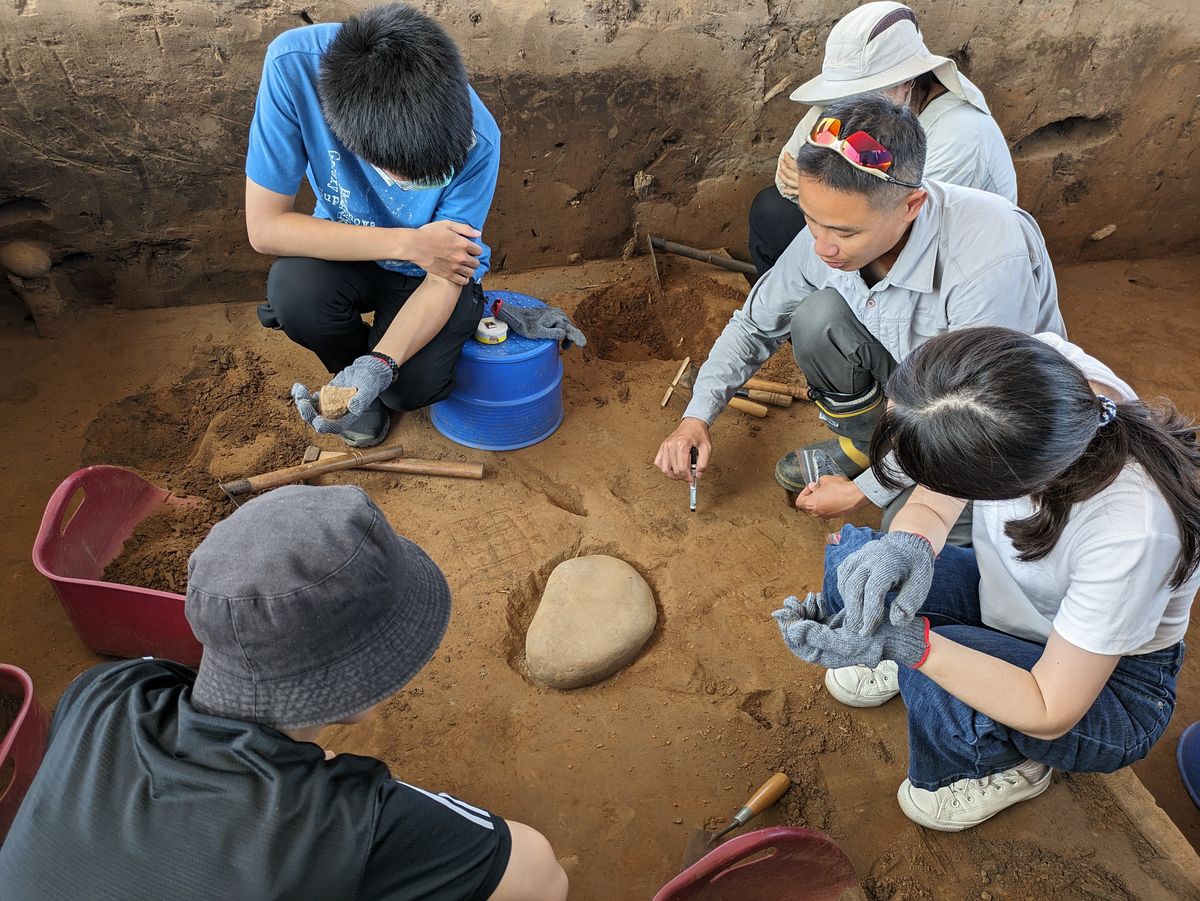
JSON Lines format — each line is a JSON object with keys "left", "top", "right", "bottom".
{"left": 0, "top": 486, "right": 566, "bottom": 901}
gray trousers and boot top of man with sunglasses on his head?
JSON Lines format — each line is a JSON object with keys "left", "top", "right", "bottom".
{"left": 792, "top": 288, "right": 971, "bottom": 547}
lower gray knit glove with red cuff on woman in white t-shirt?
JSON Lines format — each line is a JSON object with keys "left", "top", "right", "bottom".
{"left": 772, "top": 594, "right": 929, "bottom": 669}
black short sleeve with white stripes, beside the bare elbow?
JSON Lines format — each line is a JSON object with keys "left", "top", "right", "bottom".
{"left": 359, "top": 780, "right": 512, "bottom": 901}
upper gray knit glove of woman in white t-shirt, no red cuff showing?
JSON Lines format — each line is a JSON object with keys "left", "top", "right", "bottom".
{"left": 838, "top": 531, "right": 934, "bottom": 636}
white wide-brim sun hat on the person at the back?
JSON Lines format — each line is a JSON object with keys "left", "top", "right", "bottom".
{"left": 791, "top": 2, "right": 989, "bottom": 113}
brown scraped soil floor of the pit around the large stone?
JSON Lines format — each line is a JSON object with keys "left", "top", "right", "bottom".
{"left": 0, "top": 260, "right": 1200, "bottom": 901}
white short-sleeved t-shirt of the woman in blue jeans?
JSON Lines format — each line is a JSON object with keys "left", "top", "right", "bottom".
{"left": 972, "top": 334, "right": 1200, "bottom": 656}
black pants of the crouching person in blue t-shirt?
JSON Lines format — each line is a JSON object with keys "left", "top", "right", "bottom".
{"left": 258, "top": 257, "right": 484, "bottom": 410}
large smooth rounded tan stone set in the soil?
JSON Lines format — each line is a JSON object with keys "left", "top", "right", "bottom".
{"left": 526, "top": 555, "right": 659, "bottom": 689}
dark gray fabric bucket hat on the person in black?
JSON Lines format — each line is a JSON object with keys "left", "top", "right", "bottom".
{"left": 184, "top": 485, "right": 450, "bottom": 728}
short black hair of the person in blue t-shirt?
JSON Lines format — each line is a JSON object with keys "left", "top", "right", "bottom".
{"left": 318, "top": 4, "right": 474, "bottom": 181}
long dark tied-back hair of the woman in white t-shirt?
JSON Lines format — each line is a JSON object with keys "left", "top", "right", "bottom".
{"left": 871, "top": 326, "right": 1200, "bottom": 588}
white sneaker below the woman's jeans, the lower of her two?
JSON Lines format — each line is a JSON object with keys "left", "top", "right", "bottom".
{"left": 896, "top": 767, "right": 1054, "bottom": 833}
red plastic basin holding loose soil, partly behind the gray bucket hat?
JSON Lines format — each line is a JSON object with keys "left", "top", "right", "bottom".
{"left": 34, "top": 465, "right": 200, "bottom": 666}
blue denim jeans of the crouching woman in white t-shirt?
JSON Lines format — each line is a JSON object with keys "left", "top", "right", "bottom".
{"left": 823, "top": 525, "right": 1183, "bottom": 791}
